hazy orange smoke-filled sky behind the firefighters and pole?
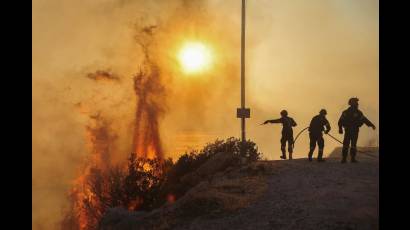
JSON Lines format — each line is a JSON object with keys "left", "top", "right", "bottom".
{"left": 32, "top": 0, "right": 379, "bottom": 229}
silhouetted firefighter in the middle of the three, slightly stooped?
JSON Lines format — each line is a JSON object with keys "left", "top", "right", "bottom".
{"left": 308, "top": 109, "right": 330, "bottom": 162}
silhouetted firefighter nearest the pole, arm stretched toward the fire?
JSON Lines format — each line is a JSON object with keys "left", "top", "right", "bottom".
{"left": 263, "top": 110, "right": 297, "bottom": 160}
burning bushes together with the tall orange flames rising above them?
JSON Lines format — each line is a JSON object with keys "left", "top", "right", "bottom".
{"left": 61, "top": 12, "right": 260, "bottom": 230}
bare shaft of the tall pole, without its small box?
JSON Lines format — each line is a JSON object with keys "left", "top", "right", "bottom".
{"left": 241, "top": 0, "right": 246, "bottom": 144}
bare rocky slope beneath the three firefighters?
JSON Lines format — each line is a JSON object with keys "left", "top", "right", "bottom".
{"left": 100, "top": 148, "right": 379, "bottom": 230}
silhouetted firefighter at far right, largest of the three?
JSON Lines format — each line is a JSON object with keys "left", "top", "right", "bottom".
{"left": 338, "top": 98, "right": 376, "bottom": 163}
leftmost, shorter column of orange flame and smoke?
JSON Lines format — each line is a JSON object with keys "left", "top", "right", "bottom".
{"left": 60, "top": 113, "right": 117, "bottom": 229}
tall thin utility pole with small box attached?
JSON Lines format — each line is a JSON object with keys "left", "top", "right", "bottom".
{"left": 236, "top": 0, "right": 250, "bottom": 155}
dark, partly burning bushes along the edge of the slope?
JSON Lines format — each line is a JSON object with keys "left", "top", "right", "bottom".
{"left": 62, "top": 138, "right": 260, "bottom": 229}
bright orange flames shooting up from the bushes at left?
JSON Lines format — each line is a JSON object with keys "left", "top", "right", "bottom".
{"left": 63, "top": 68, "right": 167, "bottom": 230}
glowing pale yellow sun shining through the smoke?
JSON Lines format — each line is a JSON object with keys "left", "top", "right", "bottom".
{"left": 178, "top": 42, "right": 211, "bottom": 74}
